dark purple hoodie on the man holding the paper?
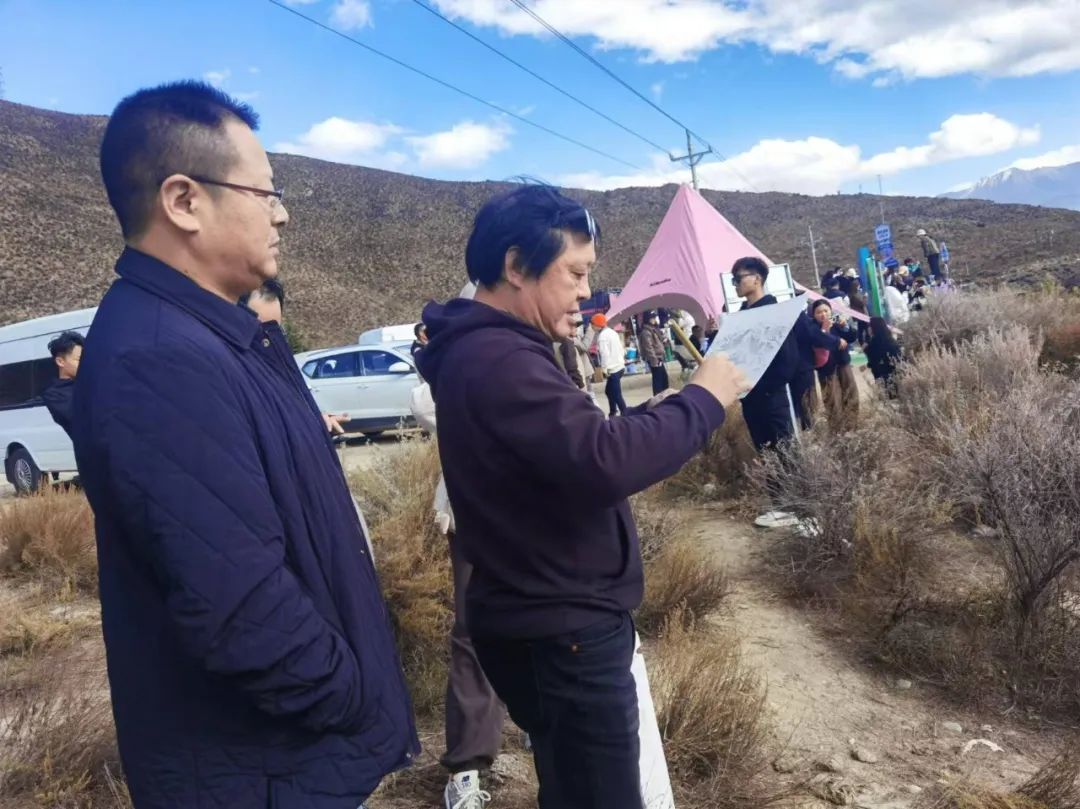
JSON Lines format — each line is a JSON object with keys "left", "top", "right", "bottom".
{"left": 417, "top": 299, "right": 724, "bottom": 638}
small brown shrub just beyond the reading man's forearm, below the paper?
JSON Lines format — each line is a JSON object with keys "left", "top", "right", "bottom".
{"left": 664, "top": 404, "right": 757, "bottom": 499}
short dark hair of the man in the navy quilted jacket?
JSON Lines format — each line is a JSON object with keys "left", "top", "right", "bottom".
{"left": 100, "top": 81, "right": 259, "bottom": 239}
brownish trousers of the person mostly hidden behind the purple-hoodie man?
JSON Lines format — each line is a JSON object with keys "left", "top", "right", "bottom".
{"left": 442, "top": 534, "right": 505, "bottom": 773}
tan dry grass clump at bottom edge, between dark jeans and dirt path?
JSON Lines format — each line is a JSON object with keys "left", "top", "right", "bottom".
{"left": 650, "top": 615, "right": 770, "bottom": 809}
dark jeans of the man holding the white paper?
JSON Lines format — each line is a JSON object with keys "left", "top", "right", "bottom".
{"left": 473, "top": 612, "right": 642, "bottom": 809}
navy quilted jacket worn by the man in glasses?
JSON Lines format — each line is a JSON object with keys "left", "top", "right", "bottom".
{"left": 73, "top": 248, "right": 418, "bottom": 809}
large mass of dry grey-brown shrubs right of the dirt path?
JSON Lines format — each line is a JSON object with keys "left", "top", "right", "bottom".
{"left": 756, "top": 293, "right": 1080, "bottom": 717}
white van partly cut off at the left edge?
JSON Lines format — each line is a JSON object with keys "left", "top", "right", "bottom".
{"left": 0, "top": 308, "right": 97, "bottom": 494}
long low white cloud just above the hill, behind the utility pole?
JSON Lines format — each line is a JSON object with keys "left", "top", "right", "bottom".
{"left": 559, "top": 112, "right": 1039, "bottom": 194}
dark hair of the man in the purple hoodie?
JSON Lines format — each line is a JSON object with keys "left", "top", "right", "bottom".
{"left": 465, "top": 185, "right": 600, "bottom": 288}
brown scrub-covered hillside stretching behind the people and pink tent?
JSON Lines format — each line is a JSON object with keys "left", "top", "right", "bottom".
{"left": 0, "top": 102, "right": 1080, "bottom": 346}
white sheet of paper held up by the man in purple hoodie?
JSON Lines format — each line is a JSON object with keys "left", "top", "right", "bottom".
{"left": 707, "top": 296, "right": 806, "bottom": 387}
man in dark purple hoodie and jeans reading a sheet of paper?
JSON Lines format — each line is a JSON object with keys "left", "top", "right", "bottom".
{"left": 418, "top": 185, "right": 745, "bottom": 809}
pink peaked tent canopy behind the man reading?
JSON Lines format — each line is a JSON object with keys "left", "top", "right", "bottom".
{"left": 607, "top": 186, "right": 867, "bottom": 323}
